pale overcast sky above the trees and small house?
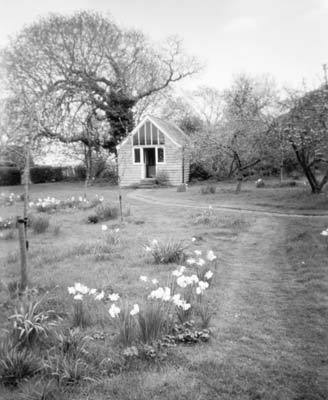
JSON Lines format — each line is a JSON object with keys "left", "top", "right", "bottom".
{"left": 0, "top": 0, "right": 328, "bottom": 88}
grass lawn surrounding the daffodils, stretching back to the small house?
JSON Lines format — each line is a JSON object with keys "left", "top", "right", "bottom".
{"left": 0, "top": 184, "right": 328, "bottom": 400}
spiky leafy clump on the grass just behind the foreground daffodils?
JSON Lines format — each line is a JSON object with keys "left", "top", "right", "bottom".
{"left": 144, "top": 239, "right": 186, "bottom": 264}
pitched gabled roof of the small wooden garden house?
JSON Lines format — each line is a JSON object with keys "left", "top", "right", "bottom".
{"left": 117, "top": 115, "right": 190, "bottom": 149}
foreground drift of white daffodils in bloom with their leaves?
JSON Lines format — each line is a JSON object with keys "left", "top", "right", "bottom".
{"left": 68, "top": 244, "right": 216, "bottom": 347}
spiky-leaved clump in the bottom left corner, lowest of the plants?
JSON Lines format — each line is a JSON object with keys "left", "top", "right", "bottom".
{"left": 0, "top": 339, "right": 41, "bottom": 386}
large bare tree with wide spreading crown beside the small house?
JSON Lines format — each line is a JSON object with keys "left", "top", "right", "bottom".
{"left": 2, "top": 11, "right": 199, "bottom": 152}
